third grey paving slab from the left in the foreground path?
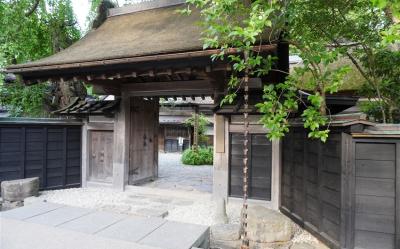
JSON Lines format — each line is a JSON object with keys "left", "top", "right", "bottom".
{"left": 59, "top": 212, "right": 127, "bottom": 234}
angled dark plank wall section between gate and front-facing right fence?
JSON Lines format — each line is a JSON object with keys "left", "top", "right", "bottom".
{"left": 281, "top": 129, "right": 341, "bottom": 248}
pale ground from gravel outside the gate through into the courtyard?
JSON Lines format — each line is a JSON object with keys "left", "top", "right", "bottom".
{"left": 18, "top": 153, "right": 317, "bottom": 244}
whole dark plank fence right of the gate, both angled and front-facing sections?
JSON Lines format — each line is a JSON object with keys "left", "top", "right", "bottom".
{"left": 281, "top": 127, "right": 400, "bottom": 249}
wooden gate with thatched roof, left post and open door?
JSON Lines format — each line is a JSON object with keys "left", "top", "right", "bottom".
{"left": 7, "top": 1, "right": 288, "bottom": 193}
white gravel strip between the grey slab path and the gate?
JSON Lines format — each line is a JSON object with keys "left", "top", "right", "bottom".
{"left": 26, "top": 187, "right": 318, "bottom": 244}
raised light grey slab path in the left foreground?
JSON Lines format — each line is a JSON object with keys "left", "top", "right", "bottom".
{"left": 0, "top": 202, "right": 209, "bottom": 249}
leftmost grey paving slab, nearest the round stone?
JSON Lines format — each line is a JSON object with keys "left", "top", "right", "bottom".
{"left": 1, "top": 202, "right": 63, "bottom": 220}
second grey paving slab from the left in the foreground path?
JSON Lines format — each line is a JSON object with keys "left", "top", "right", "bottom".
{"left": 26, "top": 207, "right": 93, "bottom": 226}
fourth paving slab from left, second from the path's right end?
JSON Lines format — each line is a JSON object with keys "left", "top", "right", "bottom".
{"left": 97, "top": 217, "right": 167, "bottom": 242}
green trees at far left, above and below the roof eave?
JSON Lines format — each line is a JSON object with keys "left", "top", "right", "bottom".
{"left": 0, "top": 0, "right": 80, "bottom": 116}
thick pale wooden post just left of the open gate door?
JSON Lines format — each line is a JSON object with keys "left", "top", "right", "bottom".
{"left": 113, "top": 93, "right": 131, "bottom": 191}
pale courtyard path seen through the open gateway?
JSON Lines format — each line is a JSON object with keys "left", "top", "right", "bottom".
{"left": 145, "top": 153, "right": 213, "bottom": 193}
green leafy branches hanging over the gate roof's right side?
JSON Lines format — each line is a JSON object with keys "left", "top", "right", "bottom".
{"left": 182, "top": 0, "right": 399, "bottom": 141}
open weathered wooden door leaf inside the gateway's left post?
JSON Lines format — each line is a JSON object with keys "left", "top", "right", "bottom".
{"left": 129, "top": 97, "right": 159, "bottom": 184}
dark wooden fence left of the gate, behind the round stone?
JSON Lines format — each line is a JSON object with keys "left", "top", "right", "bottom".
{"left": 0, "top": 119, "right": 81, "bottom": 189}
